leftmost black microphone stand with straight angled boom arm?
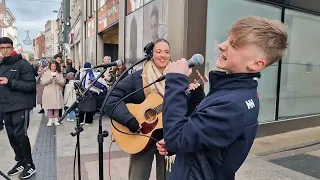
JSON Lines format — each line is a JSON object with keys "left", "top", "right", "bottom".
{"left": 59, "top": 69, "right": 108, "bottom": 180}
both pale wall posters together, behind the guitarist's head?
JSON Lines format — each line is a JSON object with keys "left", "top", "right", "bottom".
{"left": 125, "top": 0, "right": 168, "bottom": 73}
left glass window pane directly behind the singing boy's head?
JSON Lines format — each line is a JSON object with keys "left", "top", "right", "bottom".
{"left": 205, "top": 0, "right": 281, "bottom": 122}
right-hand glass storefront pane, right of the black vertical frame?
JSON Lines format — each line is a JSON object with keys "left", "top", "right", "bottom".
{"left": 279, "top": 10, "right": 320, "bottom": 118}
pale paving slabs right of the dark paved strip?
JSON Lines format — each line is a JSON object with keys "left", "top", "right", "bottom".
{"left": 57, "top": 114, "right": 320, "bottom": 180}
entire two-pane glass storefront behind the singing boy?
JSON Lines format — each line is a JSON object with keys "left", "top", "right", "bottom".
{"left": 205, "top": 0, "right": 320, "bottom": 122}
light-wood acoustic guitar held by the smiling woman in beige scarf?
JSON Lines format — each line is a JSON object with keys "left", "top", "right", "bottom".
{"left": 111, "top": 72, "right": 208, "bottom": 154}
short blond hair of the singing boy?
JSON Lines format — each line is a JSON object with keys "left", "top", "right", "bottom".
{"left": 229, "top": 16, "right": 288, "bottom": 66}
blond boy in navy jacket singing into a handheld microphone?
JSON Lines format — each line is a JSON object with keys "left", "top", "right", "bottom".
{"left": 157, "top": 16, "right": 288, "bottom": 180}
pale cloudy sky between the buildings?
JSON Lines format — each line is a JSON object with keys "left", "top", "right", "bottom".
{"left": 6, "top": 0, "right": 61, "bottom": 51}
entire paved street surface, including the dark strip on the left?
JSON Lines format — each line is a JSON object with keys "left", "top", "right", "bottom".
{"left": 0, "top": 106, "right": 320, "bottom": 180}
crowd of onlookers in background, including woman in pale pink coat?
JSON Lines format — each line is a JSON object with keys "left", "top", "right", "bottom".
{"left": 34, "top": 54, "right": 124, "bottom": 126}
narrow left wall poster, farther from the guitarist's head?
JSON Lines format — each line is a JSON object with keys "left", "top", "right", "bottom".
{"left": 125, "top": 8, "right": 144, "bottom": 73}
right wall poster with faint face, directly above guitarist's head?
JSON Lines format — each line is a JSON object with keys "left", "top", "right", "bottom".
{"left": 143, "top": 0, "right": 168, "bottom": 45}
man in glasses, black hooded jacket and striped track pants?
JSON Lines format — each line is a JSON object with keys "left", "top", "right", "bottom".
{"left": 0, "top": 37, "right": 36, "bottom": 179}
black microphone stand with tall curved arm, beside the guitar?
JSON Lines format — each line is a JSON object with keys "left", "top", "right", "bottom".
{"left": 97, "top": 55, "right": 152, "bottom": 180}
